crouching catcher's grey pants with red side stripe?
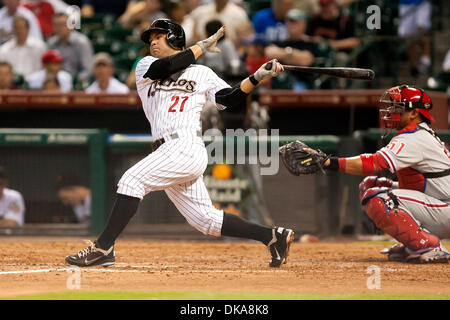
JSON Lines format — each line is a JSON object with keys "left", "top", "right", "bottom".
{"left": 377, "top": 189, "right": 450, "bottom": 239}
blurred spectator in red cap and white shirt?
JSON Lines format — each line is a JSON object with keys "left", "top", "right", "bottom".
{"left": 25, "top": 50, "right": 72, "bottom": 93}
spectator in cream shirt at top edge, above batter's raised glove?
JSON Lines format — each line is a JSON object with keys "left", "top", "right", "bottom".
{"left": 190, "top": 0, "right": 251, "bottom": 45}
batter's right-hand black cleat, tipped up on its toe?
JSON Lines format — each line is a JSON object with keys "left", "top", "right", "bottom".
{"left": 267, "top": 227, "right": 294, "bottom": 268}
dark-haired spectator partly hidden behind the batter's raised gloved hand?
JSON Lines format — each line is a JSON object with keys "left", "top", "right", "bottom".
{"left": 200, "top": 20, "right": 241, "bottom": 80}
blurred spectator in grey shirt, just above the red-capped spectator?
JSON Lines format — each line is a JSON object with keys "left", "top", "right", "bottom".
{"left": 48, "top": 13, "right": 94, "bottom": 82}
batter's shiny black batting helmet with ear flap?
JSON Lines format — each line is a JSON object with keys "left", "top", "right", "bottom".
{"left": 141, "top": 19, "right": 186, "bottom": 50}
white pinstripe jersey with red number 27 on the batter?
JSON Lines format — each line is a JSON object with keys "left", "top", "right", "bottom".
{"left": 136, "top": 56, "right": 230, "bottom": 139}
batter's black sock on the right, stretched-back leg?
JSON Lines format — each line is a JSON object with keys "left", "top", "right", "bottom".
{"left": 221, "top": 212, "right": 272, "bottom": 246}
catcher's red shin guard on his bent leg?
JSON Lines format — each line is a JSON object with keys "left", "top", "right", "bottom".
{"left": 361, "top": 188, "right": 439, "bottom": 251}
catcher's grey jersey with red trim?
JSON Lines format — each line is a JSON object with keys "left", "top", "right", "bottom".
{"left": 378, "top": 122, "right": 450, "bottom": 204}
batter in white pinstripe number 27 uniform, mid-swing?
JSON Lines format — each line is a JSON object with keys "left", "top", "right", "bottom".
{"left": 66, "top": 19, "right": 294, "bottom": 267}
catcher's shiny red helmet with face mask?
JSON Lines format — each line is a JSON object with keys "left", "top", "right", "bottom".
{"left": 380, "top": 84, "right": 434, "bottom": 129}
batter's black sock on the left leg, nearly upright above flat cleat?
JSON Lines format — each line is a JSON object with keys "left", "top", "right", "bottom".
{"left": 97, "top": 194, "right": 140, "bottom": 250}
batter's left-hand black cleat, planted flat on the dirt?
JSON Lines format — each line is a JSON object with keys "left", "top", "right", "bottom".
{"left": 66, "top": 240, "right": 116, "bottom": 267}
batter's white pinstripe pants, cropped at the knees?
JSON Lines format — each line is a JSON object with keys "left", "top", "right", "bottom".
{"left": 117, "top": 136, "right": 223, "bottom": 236}
